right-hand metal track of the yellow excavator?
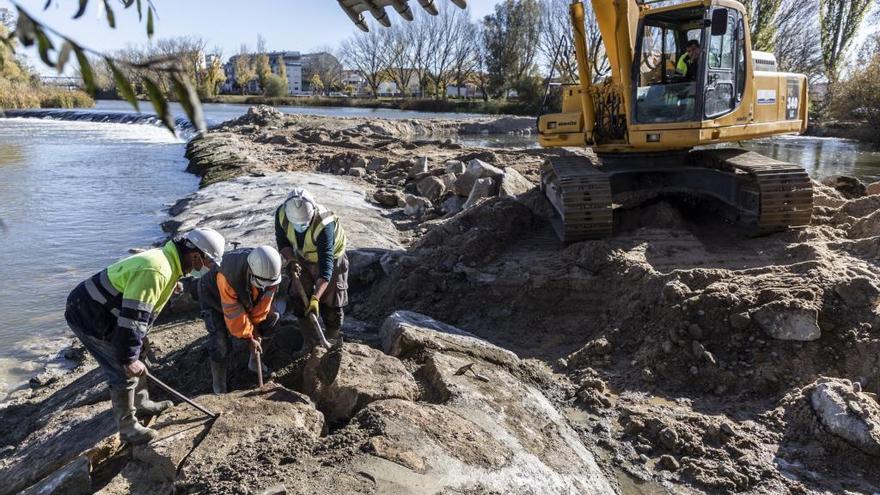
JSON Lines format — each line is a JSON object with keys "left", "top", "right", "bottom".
{"left": 691, "top": 148, "right": 813, "bottom": 234}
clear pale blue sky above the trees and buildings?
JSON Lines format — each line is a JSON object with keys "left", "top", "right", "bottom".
{"left": 0, "top": 0, "right": 500, "bottom": 74}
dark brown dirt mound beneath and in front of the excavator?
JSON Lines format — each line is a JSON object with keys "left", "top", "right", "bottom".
{"left": 358, "top": 184, "right": 880, "bottom": 492}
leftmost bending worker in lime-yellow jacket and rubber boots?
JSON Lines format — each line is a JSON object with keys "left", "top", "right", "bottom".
{"left": 64, "top": 229, "right": 226, "bottom": 444}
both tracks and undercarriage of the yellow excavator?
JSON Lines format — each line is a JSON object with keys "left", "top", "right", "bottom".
{"left": 541, "top": 148, "right": 813, "bottom": 243}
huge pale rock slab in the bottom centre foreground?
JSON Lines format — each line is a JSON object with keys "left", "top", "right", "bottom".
{"left": 360, "top": 311, "right": 615, "bottom": 495}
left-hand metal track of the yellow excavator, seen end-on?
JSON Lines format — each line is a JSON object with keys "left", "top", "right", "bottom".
{"left": 541, "top": 156, "right": 614, "bottom": 242}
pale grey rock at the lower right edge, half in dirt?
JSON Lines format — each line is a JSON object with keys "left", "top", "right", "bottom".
{"left": 810, "top": 379, "right": 880, "bottom": 456}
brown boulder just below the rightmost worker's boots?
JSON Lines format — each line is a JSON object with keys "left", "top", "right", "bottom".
{"left": 301, "top": 344, "right": 419, "bottom": 423}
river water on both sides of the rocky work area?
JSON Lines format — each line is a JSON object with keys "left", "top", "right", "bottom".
{"left": 0, "top": 101, "right": 880, "bottom": 402}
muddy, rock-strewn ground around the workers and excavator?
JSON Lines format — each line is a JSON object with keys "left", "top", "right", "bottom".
{"left": 0, "top": 109, "right": 880, "bottom": 494}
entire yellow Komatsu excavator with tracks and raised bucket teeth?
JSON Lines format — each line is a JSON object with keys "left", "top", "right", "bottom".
{"left": 339, "top": 0, "right": 813, "bottom": 242}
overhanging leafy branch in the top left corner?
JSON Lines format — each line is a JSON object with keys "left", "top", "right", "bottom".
{"left": 0, "top": 0, "right": 205, "bottom": 132}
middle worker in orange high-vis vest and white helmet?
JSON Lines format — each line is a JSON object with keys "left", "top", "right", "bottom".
{"left": 198, "top": 246, "right": 281, "bottom": 394}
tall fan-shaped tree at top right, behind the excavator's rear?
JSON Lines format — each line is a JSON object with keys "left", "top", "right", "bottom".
{"left": 819, "top": 0, "right": 872, "bottom": 84}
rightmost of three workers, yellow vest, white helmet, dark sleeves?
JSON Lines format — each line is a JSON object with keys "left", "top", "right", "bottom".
{"left": 275, "top": 188, "right": 348, "bottom": 351}
